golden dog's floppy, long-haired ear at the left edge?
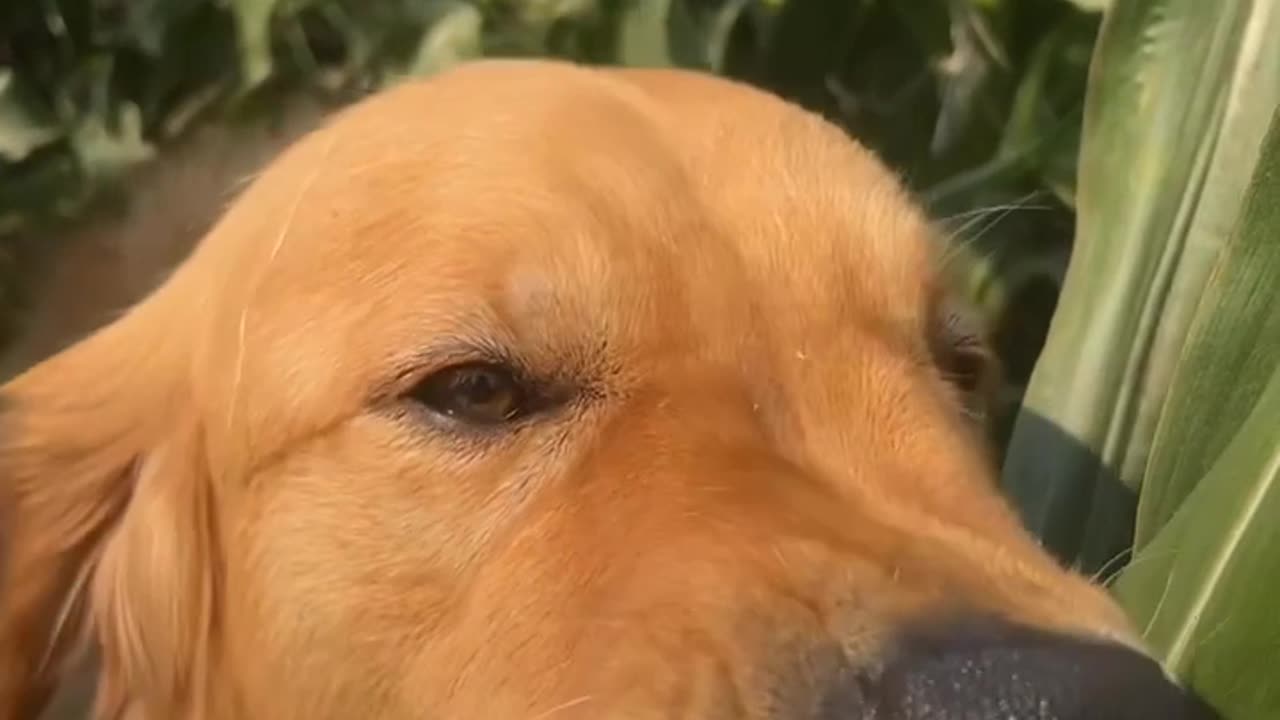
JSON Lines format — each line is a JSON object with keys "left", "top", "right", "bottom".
{"left": 0, "top": 298, "right": 211, "bottom": 720}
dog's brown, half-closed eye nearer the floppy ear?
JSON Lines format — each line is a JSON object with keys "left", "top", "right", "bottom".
{"left": 410, "top": 363, "right": 530, "bottom": 425}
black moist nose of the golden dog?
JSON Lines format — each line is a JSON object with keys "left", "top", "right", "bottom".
{"left": 818, "top": 609, "right": 1219, "bottom": 720}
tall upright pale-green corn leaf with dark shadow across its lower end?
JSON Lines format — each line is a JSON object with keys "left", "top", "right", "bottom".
{"left": 1005, "top": 0, "right": 1280, "bottom": 569}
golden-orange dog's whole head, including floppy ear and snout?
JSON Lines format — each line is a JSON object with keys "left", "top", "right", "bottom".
{"left": 0, "top": 61, "right": 1213, "bottom": 720}
